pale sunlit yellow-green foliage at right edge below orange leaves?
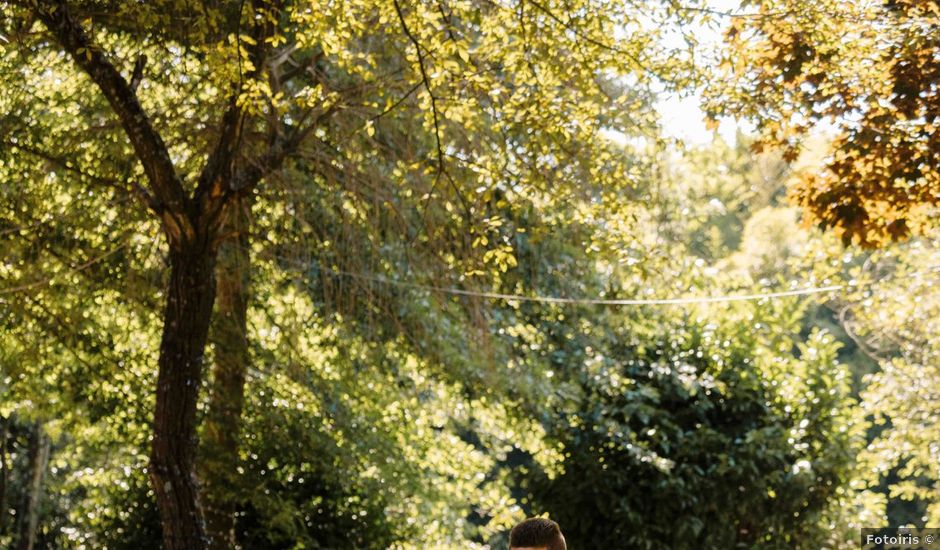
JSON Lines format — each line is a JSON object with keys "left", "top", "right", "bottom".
{"left": 837, "top": 231, "right": 940, "bottom": 525}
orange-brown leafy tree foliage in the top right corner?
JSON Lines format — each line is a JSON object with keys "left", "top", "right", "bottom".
{"left": 709, "top": 0, "right": 940, "bottom": 247}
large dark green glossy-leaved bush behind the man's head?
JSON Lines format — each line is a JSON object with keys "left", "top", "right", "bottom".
{"left": 527, "top": 302, "right": 864, "bottom": 548}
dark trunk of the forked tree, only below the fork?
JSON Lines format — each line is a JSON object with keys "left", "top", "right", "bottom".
{"left": 150, "top": 243, "right": 215, "bottom": 550}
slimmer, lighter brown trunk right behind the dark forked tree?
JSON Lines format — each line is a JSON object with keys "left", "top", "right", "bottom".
{"left": 199, "top": 198, "right": 251, "bottom": 550}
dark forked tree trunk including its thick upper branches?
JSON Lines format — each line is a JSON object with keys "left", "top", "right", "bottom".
{"left": 31, "top": 4, "right": 286, "bottom": 550}
